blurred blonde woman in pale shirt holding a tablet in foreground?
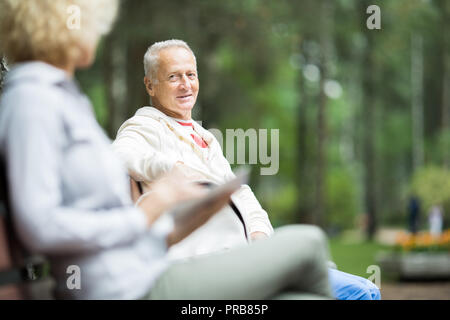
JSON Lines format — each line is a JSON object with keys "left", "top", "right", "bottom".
{"left": 0, "top": 0, "right": 331, "bottom": 299}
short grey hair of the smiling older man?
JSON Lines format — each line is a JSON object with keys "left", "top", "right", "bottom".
{"left": 144, "top": 39, "right": 197, "bottom": 83}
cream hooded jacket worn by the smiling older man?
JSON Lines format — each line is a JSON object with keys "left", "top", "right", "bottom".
{"left": 113, "top": 107, "right": 273, "bottom": 259}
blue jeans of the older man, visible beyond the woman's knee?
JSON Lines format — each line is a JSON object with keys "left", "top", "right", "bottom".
{"left": 328, "top": 268, "right": 381, "bottom": 300}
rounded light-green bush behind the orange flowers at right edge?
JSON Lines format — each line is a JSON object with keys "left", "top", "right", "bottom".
{"left": 411, "top": 166, "right": 450, "bottom": 214}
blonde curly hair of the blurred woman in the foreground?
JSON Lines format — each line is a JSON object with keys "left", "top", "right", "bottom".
{"left": 0, "top": 0, "right": 119, "bottom": 65}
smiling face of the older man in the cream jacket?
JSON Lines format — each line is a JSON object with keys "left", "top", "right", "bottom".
{"left": 145, "top": 47, "right": 199, "bottom": 120}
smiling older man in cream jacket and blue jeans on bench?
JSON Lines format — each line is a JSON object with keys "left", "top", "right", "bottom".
{"left": 113, "top": 40, "right": 380, "bottom": 300}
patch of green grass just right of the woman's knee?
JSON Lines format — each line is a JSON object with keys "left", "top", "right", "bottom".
{"left": 329, "top": 239, "right": 388, "bottom": 278}
